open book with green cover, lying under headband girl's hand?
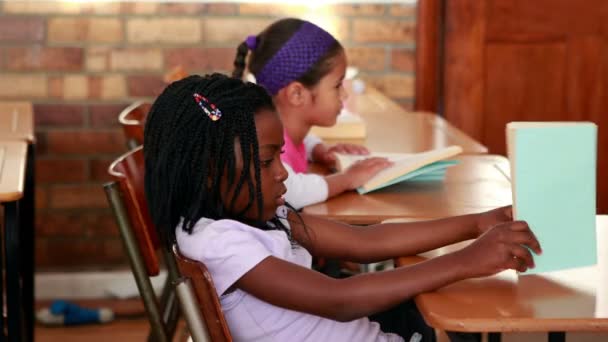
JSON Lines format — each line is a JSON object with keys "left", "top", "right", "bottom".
{"left": 336, "top": 146, "right": 462, "bottom": 194}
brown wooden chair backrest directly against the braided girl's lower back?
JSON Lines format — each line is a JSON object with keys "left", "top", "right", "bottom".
{"left": 173, "top": 246, "right": 232, "bottom": 342}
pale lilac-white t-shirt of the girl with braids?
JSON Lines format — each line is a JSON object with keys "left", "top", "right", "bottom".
{"left": 176, "top": 207, "right": 403, "bottom": 342}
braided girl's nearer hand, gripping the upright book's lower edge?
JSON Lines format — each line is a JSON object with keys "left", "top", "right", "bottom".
{"left": 456, "top": 221, "right": 542, "bottom": 277}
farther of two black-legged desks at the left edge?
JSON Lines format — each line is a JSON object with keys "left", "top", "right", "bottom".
{"left": 0, "top": 101, "right": 36, "bottom": 341}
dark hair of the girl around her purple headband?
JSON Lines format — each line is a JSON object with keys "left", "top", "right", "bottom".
{"left": 232, "top": 18, "right": 344, "bottom": 88}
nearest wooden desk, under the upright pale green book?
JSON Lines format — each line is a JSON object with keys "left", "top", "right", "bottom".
{"left": 396, "top": 216, "right": 608, "bottom": 341}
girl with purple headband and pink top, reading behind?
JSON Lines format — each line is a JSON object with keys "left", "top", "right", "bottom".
{"left": 233, "top": 18, "right": 390, "bottom": 208}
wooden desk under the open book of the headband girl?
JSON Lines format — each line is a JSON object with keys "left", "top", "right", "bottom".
{"left": 303, "top": 155, "right": 512, "bottom": 224}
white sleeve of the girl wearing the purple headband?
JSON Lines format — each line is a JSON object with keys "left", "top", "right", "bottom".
{"left": 283, "top": 163, "right": 329, "bottom": 210}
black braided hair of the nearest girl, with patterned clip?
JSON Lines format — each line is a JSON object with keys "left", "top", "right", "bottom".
{"left": 144, "top": 74, "right": 290, "bottom": 246}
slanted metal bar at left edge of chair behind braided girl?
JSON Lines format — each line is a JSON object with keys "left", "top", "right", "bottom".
{"left": 104, "top": 182, "right": 170, "bottom": 342}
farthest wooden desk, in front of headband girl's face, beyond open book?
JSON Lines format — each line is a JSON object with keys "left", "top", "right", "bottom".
{"left": 326, "top": 86, "right": 488, "bottom": 154}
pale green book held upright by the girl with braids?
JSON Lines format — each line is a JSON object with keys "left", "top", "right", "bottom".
{"left": 507, "top": 122, "right": 597, "bottom": 274}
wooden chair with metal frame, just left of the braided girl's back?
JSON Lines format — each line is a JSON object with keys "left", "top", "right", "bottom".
{"left": 104, "top": 146, "right": 179, "bottom": 342}
